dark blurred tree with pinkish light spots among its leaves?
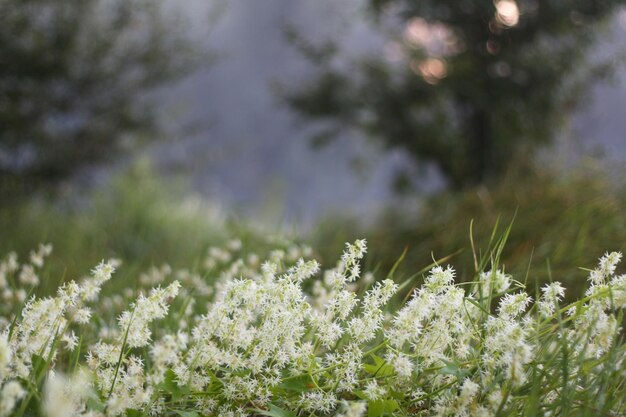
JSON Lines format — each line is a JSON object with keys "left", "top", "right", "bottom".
{"left": 281, "top": 0, "right": 624, "bottom": 188}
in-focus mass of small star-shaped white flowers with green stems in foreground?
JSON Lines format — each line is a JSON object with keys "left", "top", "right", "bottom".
{"left": 0, "top": 240, "right": 626, "bottom": 417}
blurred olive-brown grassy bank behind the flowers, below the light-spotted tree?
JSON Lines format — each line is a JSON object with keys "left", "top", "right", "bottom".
{"left": 314, "top": 163, "right": 626, "bottom": 296}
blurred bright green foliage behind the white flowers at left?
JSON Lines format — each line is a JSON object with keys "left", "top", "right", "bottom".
{"left": 0, "top": 165, "right": 227, "bottom": 288}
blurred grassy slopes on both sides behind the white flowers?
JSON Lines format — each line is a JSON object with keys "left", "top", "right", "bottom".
{"left": 0, "top": 162, "right": 626, "bottom": 296}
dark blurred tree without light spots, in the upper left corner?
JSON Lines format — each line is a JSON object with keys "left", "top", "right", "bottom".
{"left": 0, "top": 0, "right": 193, "bottom": 195}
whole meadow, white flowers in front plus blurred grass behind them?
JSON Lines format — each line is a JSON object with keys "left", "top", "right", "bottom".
{"left": 0, "top": 164, "right": 626, "bottom": 417}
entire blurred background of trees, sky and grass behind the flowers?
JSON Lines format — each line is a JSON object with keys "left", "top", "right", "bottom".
{"left": 0, "top": 0, "right": 626, "bottom": 287}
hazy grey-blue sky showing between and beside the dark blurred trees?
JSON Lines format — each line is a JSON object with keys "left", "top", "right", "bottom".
{"left": 150, "top": 0, "right": 626, "bottom": 221}
